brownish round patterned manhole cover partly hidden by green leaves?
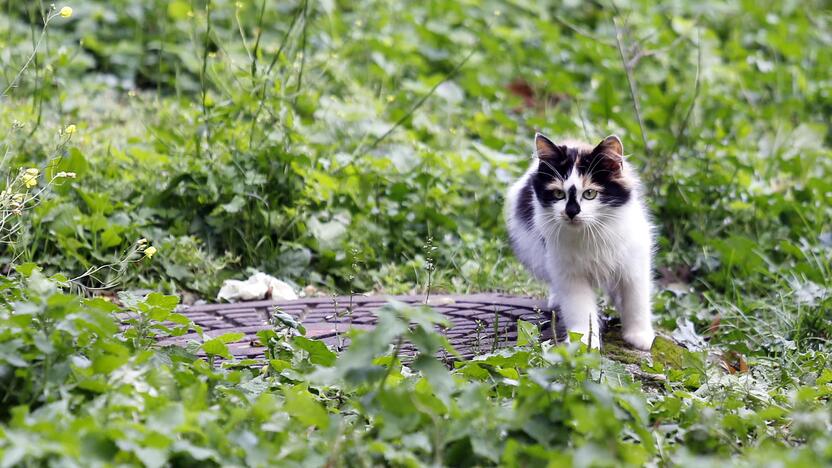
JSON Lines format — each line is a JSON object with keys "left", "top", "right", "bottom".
{"left": 161, "top": 294, "right": 551, "bottom": 359}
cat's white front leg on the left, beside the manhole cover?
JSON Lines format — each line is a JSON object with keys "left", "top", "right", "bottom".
{"left": 549, "top": 278, "right": 601, "bottom": 349}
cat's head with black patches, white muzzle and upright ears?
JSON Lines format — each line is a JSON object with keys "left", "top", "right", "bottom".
{"left": 532, "top": 133, "right": 636, "bottom": 228}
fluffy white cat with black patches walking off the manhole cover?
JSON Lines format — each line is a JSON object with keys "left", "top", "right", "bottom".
{"left": 505, "top": 133, "right": 655, "bottom": 350}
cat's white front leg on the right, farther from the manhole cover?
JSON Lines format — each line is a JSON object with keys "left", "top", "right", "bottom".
{"left": 615, "top": 265, "right": 656, "bottom": 351}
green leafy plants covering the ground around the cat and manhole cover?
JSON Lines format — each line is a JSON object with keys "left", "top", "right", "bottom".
{"left": 0, "top": 0, "right": 832, "bottom": 466}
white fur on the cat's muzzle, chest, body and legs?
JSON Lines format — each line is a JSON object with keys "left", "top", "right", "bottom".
{"left": 506, "top": 144, "right": 655, "bottom": 349}
